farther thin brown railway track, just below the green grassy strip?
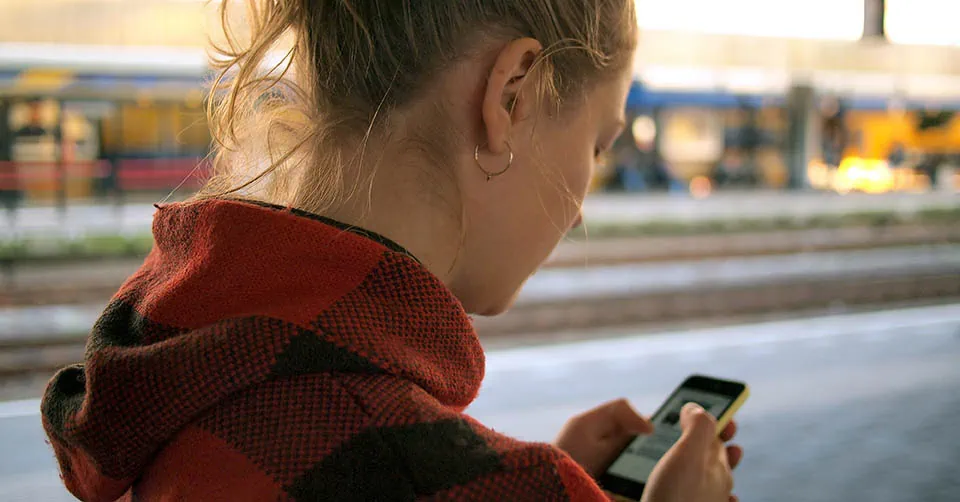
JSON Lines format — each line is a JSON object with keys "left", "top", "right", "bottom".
{"left": 0, "top": 224, "right": 960, "bottom": 307}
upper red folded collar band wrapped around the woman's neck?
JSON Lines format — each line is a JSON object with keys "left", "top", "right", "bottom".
{"left": 138, "top": 200, "right": 484, "bottom": 409}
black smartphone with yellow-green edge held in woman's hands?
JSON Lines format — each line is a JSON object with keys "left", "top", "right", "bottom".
{"left": 597, "top": 375, "right": 750, "bottom": 501}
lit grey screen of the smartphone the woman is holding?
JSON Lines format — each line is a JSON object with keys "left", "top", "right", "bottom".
{"left": 607, "top": 387, "right": 736, "bottom": 484}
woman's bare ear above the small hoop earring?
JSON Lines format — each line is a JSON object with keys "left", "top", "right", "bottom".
{"left": 483, "top": 38, "right": 543, "bottom": 155}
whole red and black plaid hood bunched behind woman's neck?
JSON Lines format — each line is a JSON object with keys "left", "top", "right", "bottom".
{"left": 41, "top": 200, "right": 484, "bottom": 500}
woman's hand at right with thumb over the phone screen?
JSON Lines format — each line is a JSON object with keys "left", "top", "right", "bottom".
{"left": 643, "top": 403, "right": 743, "bottom": 502}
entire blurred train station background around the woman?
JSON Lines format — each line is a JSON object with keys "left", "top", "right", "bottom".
{"left": 0, "top": 0, "right": 960, "bottom": 501}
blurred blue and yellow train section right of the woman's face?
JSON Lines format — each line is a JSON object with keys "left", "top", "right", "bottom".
{"left": 595, "top": 78, "right": 960, "bottom": 195}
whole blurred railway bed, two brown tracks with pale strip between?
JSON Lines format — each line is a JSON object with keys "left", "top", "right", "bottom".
{"left": 0, "top": 224, "right": 960, "bottom": 393}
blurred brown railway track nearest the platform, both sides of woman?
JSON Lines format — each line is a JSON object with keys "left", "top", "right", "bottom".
{"left": 7, "top": 252, "right": 960, "bottom": 388}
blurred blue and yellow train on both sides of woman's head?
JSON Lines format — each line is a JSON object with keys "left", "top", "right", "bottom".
{"left": 0, "top": 47, "right": 960, "bottom": 204}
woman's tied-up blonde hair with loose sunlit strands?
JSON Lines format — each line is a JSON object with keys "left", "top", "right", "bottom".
{"left": 198, "top": 0, "right": 637, "bottom": 213}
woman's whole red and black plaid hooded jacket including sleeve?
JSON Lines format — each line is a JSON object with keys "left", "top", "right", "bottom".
{"left": 42, "top": 201, "right": 606, "bottom": 501}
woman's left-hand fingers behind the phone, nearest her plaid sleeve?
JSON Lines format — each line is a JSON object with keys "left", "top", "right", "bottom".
{"left": 555, "top": 399, "right": 653, "bottom": 476}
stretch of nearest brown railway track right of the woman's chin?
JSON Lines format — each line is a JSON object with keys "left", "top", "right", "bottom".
{"left": 475, "top": 266, "right": 960, "bottom": 337}
